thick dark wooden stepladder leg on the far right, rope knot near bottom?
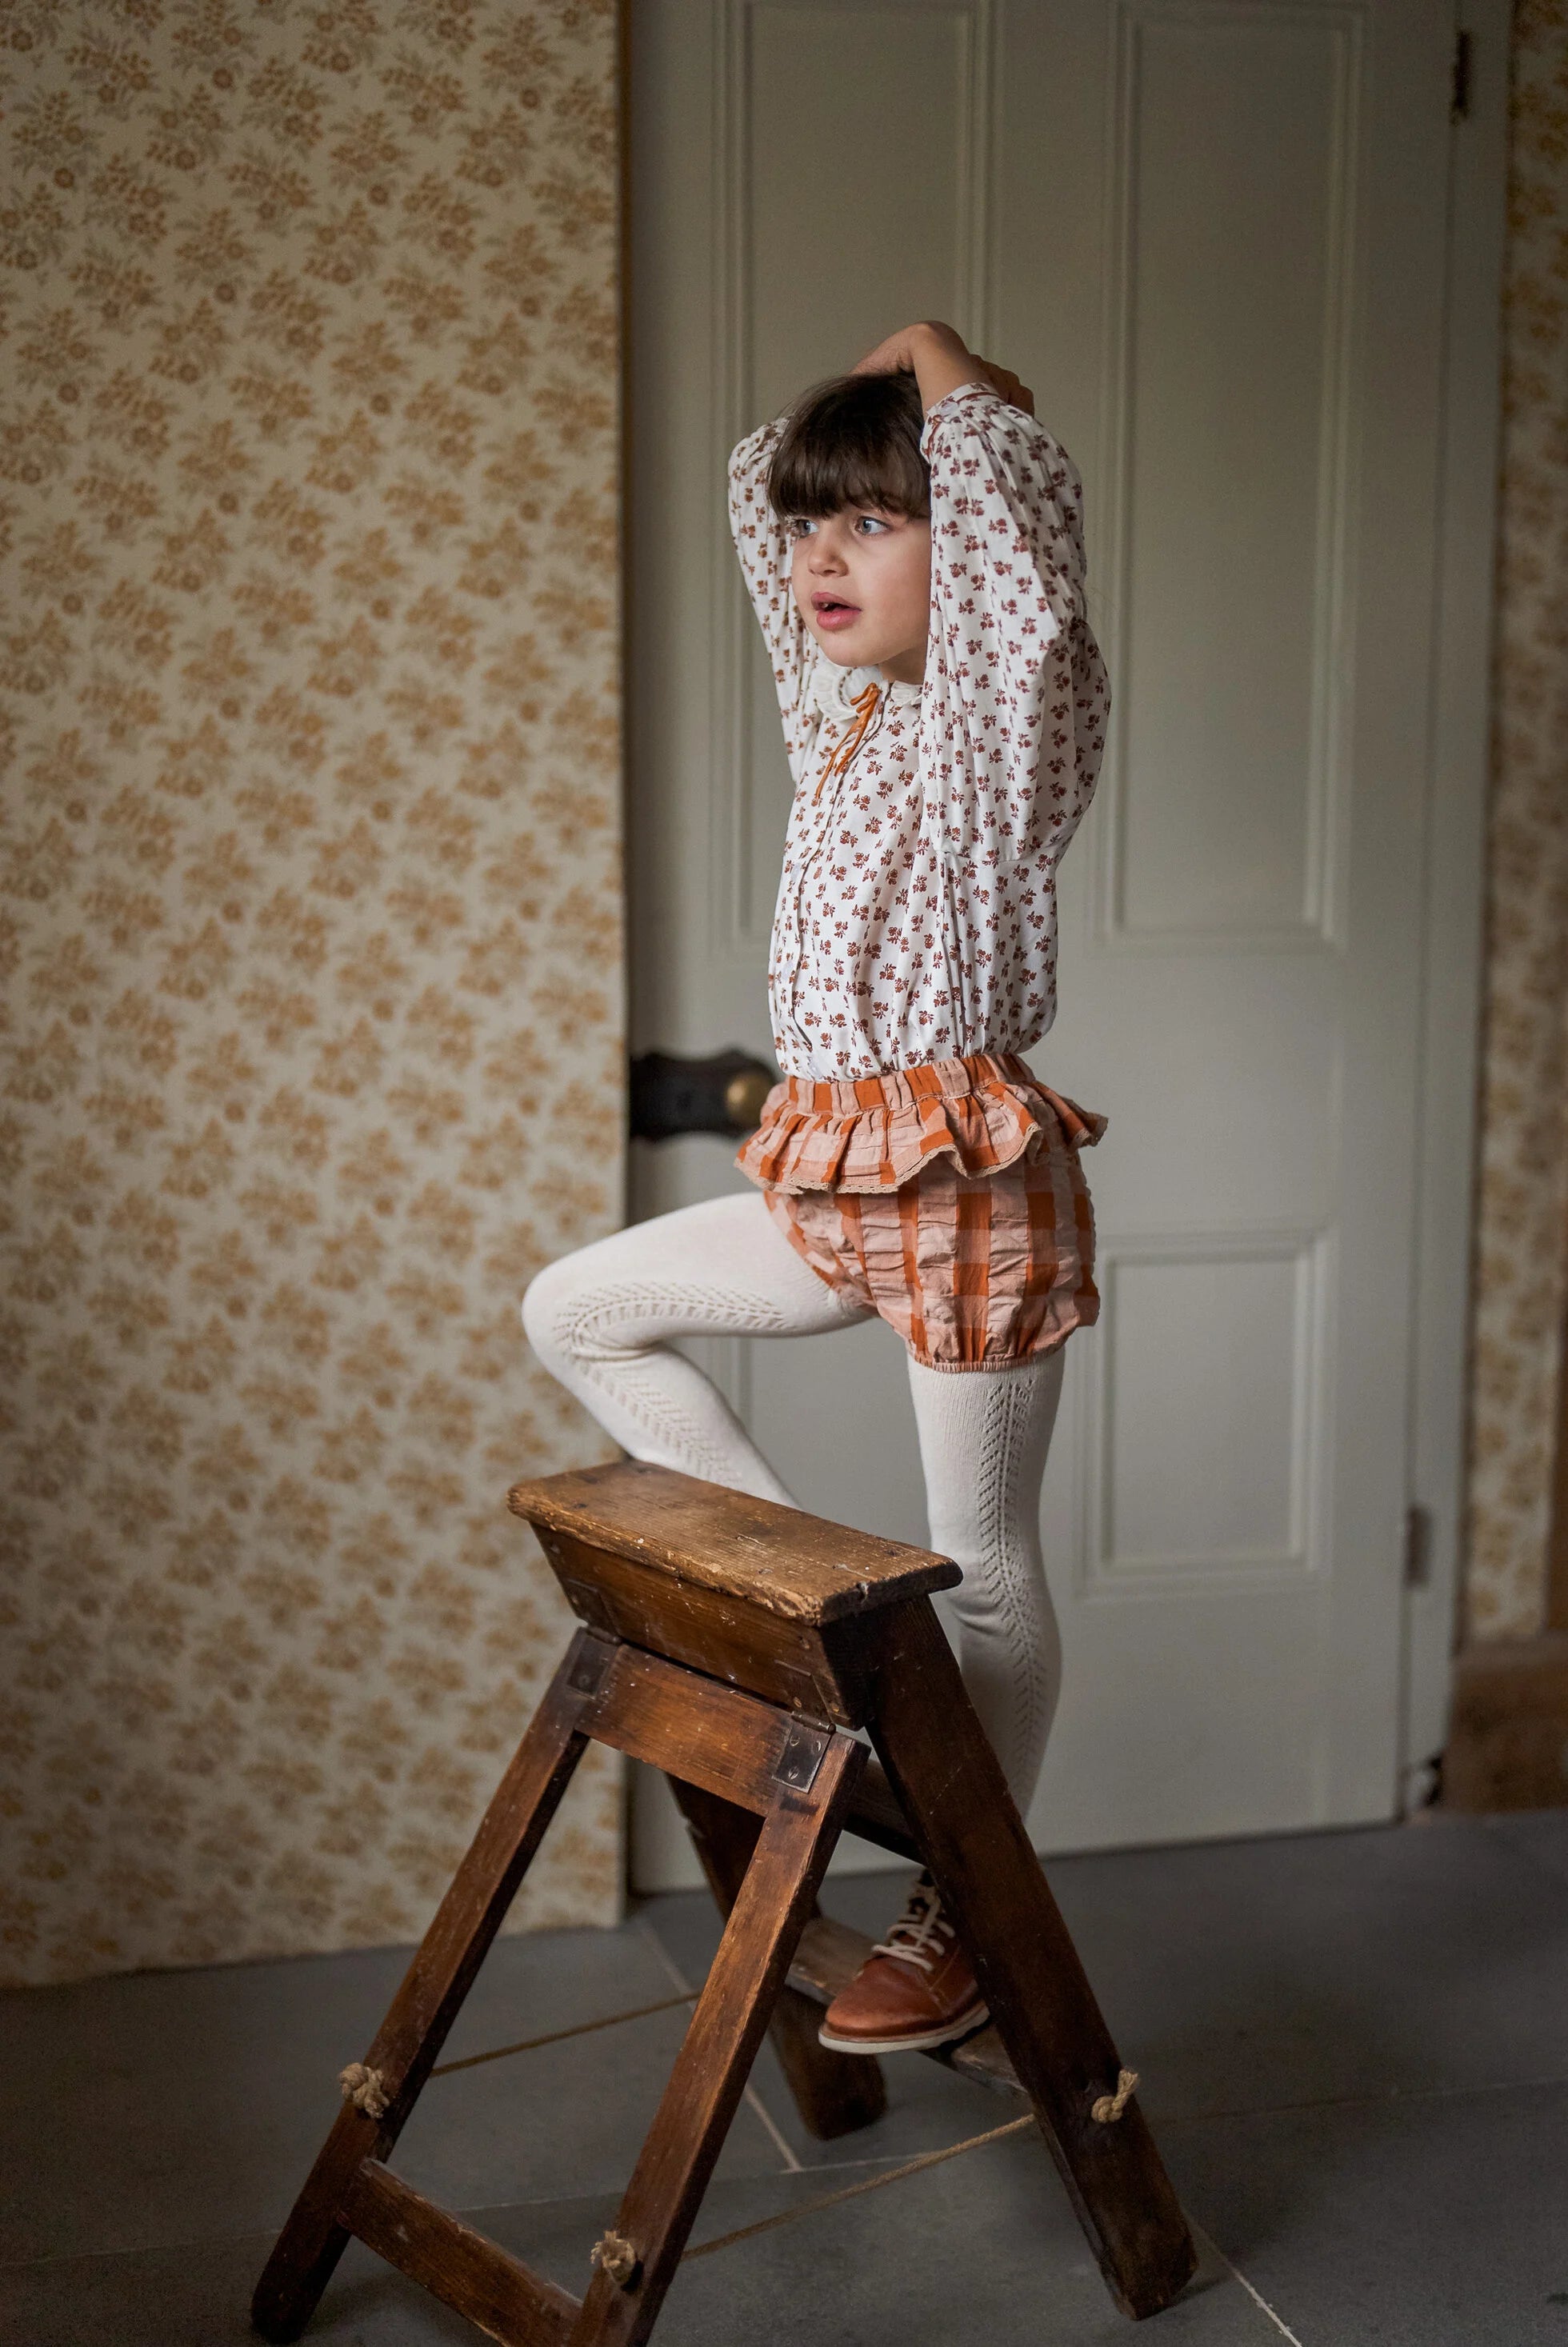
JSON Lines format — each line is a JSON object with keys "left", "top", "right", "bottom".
{"left": 871, "top": 1598, "right": 1197, "bottom": 2317}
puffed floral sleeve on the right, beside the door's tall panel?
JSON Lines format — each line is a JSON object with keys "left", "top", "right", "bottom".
{"left": 920, "top": 382, "right": 1110, "bottom": 871}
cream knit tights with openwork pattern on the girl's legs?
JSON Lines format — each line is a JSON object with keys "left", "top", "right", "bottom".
{"left": 523, "top": 1194, "right": 1061, "bottom": 1809}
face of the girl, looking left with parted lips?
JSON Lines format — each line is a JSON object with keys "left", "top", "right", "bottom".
{"left": 789, "top": 505, "right": 932, "bottom": 686}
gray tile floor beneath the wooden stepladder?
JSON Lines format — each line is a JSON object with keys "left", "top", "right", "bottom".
{"left": 0, "top": 1812, "right": 1568, "bottom": 2347}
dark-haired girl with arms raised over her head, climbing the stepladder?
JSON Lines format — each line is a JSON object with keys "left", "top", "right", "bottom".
{"left": 523, "top": 324, "right": 1108, "bottom": 2051}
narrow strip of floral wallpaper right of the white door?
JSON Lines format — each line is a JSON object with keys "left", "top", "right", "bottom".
{"left": 1465, "top": 0, "right": 1568, "bottom": 1638}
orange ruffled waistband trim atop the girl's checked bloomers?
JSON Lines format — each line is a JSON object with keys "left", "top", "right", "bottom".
{"left": 734, "top": 1051, "right": 1106, "bottom": 1192}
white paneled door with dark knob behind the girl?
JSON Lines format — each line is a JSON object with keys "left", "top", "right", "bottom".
{"left": 631, "top": 0, "right": 1460, "bottom": 1875}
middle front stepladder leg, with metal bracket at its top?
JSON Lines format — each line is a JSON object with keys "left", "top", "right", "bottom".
{"left": 568, "top": 1734, "right": 864, "bottom": 2347}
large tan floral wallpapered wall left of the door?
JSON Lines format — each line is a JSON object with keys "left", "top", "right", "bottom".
{"left": 0, "top": 0, "right": 624, "bottom": 1981}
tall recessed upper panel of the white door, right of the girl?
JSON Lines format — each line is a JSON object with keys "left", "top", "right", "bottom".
{"left": 1103, "top": 7, "right": 1359, "bottom": 942}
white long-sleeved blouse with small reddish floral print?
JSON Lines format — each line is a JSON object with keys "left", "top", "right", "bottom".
{"left": 730, "top": 382, "right": 1110, "bottom": 1080}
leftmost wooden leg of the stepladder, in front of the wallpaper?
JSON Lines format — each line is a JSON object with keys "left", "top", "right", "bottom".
{"left": 251, "top": 1631, "right": 606, "bottom": 2340}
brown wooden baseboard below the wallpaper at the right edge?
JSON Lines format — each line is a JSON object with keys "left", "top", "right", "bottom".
{"left": 1442, "top": 1631, "right": 1568, "bottom": 1814}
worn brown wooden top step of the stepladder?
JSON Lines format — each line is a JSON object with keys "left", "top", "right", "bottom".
{"left": 507, "top": 1460, "right": 962, "bottom": 1621}
